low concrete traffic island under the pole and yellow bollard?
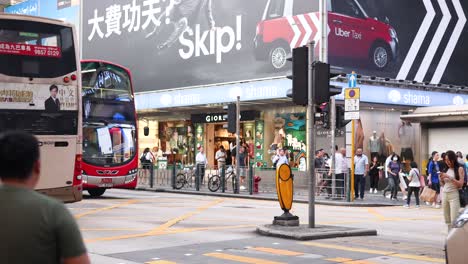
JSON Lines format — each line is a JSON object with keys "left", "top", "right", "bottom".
{"left": 256, "top": 225, "right": 377, "bottom": 240}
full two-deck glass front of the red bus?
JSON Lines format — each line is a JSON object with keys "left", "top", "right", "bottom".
{"left": 81, "top": 61, "right": 136, "bottom": 167}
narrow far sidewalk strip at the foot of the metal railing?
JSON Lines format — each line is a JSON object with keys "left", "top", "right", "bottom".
{"left": 136, "top": 185, "right": 404, "bottom": 207}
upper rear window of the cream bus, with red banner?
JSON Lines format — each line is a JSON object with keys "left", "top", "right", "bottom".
{"left": 0, "top": 19, "right": 76, "bottom": 78}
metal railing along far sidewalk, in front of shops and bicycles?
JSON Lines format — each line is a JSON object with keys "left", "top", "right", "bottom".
{"left": 137, "top": 164, "right": 349, "bottom": 199}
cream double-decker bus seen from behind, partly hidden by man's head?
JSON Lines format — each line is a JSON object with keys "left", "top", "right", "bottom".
{"left": 0, "top": 13, "right": 82, "bottom": 202}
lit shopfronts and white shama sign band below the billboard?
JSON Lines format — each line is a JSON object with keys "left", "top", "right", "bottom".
{"left": 136, "top": 79, "right": 468, "bottom": 168}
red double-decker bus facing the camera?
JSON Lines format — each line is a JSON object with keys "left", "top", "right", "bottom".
{"left": 81, "top": 60, "right": 138, "bottom": 196}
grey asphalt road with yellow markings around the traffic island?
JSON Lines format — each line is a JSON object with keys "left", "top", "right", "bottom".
{"left": 68, "top": 190, "right": 446, "bottom": 264}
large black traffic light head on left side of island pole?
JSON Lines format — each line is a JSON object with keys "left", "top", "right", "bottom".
{"left": 287, "top": 47, "right": 309, "bottom": 105}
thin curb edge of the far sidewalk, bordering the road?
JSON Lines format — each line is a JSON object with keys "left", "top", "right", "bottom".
{"left": 135, "top": 188, "right": 401, "bottom": 207}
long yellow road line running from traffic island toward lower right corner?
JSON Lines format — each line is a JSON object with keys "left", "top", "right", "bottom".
{"left": 300, "top": 242, "right": 445, "bottom": 263}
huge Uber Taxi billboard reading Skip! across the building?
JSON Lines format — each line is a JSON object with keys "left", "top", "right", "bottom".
{"left": 82, "top": 0, "right": 468, "bottom": 91}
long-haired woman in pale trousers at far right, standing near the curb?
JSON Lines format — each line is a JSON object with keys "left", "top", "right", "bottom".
{"left": 440, "top": 150, "right": 465, "bottom": 231}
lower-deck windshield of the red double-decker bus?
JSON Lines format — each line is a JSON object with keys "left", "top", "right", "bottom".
{"left": 83, "top": 122, "right": 136, "bottom": 166}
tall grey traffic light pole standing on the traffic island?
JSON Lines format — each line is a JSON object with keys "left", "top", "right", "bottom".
{"left": 307, "top": 41, "right": 316, "bottom": 228}
